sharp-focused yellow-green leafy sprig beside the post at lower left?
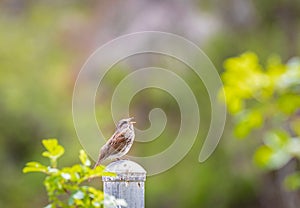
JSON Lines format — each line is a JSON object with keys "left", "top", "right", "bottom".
{"left": 23, "top": 139, "right": 126, "bottom": 208}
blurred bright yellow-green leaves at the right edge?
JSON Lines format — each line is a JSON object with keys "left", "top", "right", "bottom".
{"left": 222, "top": 52, "right": 300, "bottom": 189}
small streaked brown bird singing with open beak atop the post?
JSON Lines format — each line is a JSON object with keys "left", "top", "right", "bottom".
{"left": 94, "top": 117, "right": 136, "bottom": 168}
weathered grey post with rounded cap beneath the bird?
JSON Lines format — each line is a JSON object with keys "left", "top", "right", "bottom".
{"left": 102, "top": 160, "right": 146, "bottom": 208}
